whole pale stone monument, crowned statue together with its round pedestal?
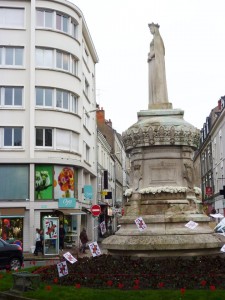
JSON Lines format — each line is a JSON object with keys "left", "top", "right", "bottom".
{"left": 102, "top": 23, "right": 225, "bottom": 256}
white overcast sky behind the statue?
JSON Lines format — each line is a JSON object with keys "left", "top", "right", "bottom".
{"left": 70, "top": 0, "right": 225, "bottom": 133}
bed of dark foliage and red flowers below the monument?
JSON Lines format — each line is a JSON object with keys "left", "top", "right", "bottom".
{"left": 35, "top": 255, "right": 225, "bottom": 293}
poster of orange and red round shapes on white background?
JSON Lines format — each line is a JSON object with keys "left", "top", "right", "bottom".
{"left": 54, "top": 166, "right": 74, "bottom": 199}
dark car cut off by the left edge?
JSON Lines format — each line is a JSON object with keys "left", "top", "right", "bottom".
{"left": 0, "top": 238, "right": 24, "bottom": 271}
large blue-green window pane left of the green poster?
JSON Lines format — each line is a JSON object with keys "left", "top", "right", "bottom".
{"left": 0, "top": 164, "right": 29, "bottom": 200}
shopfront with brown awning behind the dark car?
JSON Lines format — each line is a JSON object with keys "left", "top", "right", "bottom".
{"left": 0, "top": 207, "right": 25, "bottom": 246}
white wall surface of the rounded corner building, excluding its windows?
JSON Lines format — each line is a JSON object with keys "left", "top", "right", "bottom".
{"left": 0, "top": 0, "right": 98, "bottom": 251}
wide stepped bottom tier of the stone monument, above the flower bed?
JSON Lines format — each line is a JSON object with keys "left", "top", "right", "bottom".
{"left": 102, "top": 214, "right": 225, "bottom": 257}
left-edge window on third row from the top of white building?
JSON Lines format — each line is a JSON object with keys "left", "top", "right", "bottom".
{"left": 0, "top": 86, "right": 23, "bottom": 106}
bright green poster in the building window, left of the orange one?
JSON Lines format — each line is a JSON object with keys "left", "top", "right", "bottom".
{"left": 35, "top": 165, "right": 53, "bottom": 200}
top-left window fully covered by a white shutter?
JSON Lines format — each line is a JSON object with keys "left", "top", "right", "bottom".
{"left": 0, "top": 7, "right": 24, "bottom": 28}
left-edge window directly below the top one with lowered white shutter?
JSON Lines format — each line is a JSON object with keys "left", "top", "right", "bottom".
{"left": 0, "top": 47, "right": 23, "bottom": 66}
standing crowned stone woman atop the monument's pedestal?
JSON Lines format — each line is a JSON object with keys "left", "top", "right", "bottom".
{"left": 148, "top": 23, "right": 171, "bottom": 109}
